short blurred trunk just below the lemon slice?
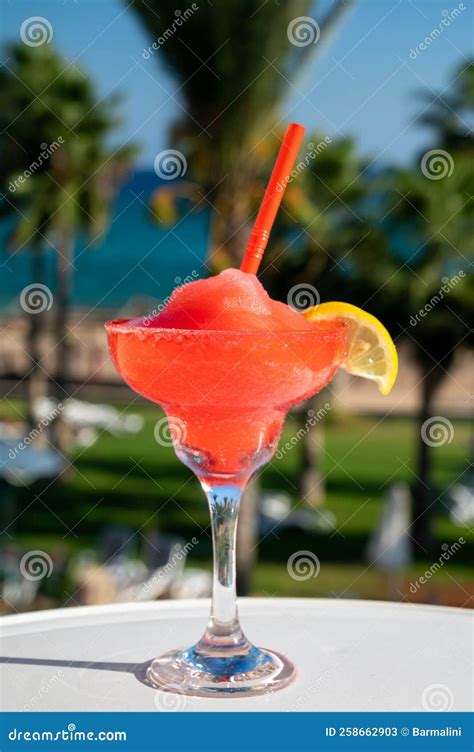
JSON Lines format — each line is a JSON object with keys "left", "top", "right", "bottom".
{"left": 298, "top": 395, "right": 326, "bottom": 507}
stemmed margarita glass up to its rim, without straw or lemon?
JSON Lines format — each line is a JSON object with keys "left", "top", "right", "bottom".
{"left": 106, "top": 314, "right": 346, "bottom": 696}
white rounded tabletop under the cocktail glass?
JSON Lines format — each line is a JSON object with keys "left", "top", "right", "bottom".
{"left": 0, "top": 598, "right": 473, "bottom": 711}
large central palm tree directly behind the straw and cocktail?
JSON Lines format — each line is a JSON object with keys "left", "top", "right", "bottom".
{"left": 128, "top": 0, "right": 353, "bottom": 594}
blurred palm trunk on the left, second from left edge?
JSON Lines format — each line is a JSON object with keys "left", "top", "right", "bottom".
{"left": 53, "top": 228, "right": 73, "bottom": 454}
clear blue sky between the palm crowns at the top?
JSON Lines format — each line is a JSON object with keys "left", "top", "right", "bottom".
{"left": 1, "top": 0, "right": 473, "bottom": 167}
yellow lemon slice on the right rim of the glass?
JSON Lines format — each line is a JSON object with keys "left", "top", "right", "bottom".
{"left": 302, "top": 303, "right": 398, "bottom": 395}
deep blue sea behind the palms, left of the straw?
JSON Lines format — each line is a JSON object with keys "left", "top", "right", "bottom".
{"left": 0, "top": 171, "right": 210, "bottom": 314}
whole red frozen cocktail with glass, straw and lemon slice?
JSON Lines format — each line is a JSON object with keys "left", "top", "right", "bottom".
{"left": 106, "top": 123, "right": 397, "bottom": 697}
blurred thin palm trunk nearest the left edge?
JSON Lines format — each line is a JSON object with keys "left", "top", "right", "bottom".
{"left": 26, "top": 248, "right": 47, "bottom": 430}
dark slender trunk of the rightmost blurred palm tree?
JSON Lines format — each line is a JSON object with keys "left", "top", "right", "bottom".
{"left": 412, "top": 369, "right": 443, "bottom": 554}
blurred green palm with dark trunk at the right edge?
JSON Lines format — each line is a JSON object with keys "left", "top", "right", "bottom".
{"left": 371, "top": 163, "right": 474, "bottom": 551}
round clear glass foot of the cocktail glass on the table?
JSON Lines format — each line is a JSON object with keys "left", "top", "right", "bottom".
{"left": 147, "top": 646, "right": 296, "bottom": 697}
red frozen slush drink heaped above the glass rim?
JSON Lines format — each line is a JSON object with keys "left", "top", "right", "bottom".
{"left": 108, "top": 269, "right": 345, "bottom": 485}
